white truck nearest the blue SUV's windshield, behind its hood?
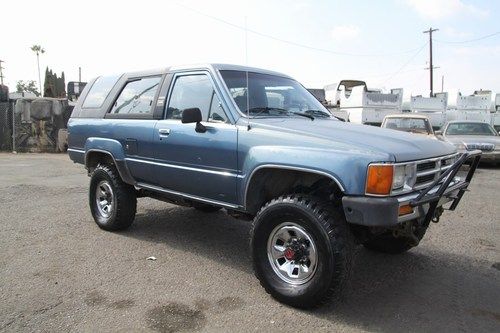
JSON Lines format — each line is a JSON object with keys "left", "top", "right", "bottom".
{"left": 325, "top": 80, "right": 403, "bottom": 126}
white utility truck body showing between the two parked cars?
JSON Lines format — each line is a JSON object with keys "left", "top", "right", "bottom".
{"left": 410, "top": 92, "right": 448, "bottom": 129}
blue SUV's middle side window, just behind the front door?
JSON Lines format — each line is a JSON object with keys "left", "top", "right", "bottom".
{"left": 110, "top": 77, "right": 160, "bottom": 114}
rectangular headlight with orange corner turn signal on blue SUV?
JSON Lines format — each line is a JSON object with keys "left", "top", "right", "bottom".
{"left": 366, "top": 163, "right": 417, "bottom": 195}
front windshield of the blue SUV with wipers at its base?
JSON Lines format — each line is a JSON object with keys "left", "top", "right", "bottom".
{"left": 220, "top": 70, "right": 331, "bottom": 118}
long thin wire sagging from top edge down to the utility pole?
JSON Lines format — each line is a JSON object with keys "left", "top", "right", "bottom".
{"left": 175, "top": 2, "right": 426, "bottom": 57}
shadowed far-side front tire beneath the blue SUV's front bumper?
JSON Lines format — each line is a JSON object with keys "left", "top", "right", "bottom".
{"left": 363, "top": 227, "right": 427, "bottom": 254}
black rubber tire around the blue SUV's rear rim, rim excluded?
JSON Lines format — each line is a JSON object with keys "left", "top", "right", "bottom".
{"left": 89, "top": 164, "right": 137, "bottom": 231}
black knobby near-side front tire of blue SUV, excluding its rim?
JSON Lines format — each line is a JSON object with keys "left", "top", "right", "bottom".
{"left": 250, "top": 194, "right": 354, "bottom": 308}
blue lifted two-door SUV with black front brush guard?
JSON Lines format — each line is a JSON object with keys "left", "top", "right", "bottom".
{"left": 68, "top": 64, "right": 480, "bottom": 308}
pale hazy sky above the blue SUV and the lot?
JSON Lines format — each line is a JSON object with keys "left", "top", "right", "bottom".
{"left": 0, "top": 0, "right": 500, "bottom": 95}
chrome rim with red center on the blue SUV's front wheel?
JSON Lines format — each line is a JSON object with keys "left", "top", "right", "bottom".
{"left": 267, "top": 222, "right": 318, "bottom": 284}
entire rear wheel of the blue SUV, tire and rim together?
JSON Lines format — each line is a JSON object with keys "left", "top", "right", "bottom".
{"left": 89, "top": 164, "right": 137, "bottom": 231}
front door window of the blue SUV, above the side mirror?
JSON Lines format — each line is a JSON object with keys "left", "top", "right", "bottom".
{"left": 167, "top": 74, "right": 214, "bottom": 120}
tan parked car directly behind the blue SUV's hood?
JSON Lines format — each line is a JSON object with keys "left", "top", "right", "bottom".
{"left": 381, "top": 114, "right": 437, "bottom": 139}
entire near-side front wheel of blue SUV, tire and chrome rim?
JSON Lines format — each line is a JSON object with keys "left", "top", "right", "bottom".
{"left": 251, "top": 194, "right": 353, "bottom": 308}
